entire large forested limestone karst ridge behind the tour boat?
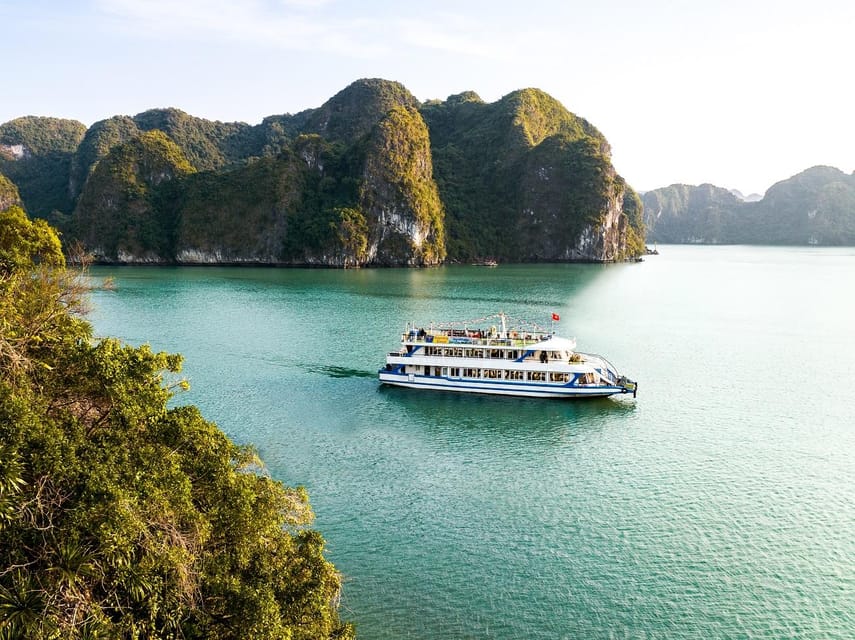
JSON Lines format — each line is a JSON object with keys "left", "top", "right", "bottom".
{"left": 0, "top": 79, "right": 645, "bottom": 267}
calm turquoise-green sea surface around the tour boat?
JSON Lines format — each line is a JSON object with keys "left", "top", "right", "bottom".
{"left": 92, "top": 246, "right": 855, "bottom": 640}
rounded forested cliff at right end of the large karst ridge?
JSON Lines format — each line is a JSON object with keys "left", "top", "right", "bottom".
{"left": 421, "top": 89, "right": 643, "bottom": 261}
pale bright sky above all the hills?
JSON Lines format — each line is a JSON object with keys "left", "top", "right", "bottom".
{"left": 0, "top": 0, "right": 855, "bottom": 195}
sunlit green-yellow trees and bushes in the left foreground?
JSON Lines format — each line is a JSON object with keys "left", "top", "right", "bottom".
{"left": 0, "top": 218, "right": 353, "bottom": 640}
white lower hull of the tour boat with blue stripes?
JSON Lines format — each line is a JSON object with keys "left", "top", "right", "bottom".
{"left": 379, "top": 371, "right": 631, "bottom": 398}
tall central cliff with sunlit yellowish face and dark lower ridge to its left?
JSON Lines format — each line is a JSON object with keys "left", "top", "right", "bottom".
{"left": 175, "top": 82, "right": 445, "bottom": 267}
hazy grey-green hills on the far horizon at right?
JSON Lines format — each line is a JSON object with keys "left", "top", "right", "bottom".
{"left": 642, "top": 166, "right": 855, "bottom": 246}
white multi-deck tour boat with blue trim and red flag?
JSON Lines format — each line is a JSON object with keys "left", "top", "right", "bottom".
{"left": 378, "top": 313, "right": 638, "bottom": 398}
